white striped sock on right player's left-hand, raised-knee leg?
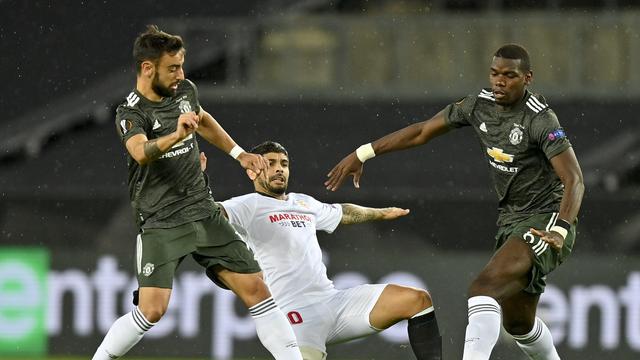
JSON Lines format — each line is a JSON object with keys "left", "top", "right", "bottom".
{"left": 462, "top": 296, "right": 502, "bottom": 360}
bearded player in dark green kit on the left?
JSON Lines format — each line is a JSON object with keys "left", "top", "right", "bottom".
{"left": 93, "top": 25, "right": 302, "bottom": 360}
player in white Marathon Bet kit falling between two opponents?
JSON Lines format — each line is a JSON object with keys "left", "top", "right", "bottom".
{"left": 212, "top": 141, "right": 442, "bottom": 360}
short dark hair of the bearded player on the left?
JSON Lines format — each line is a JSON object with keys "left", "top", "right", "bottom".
{"left": 133, "top": 25, "right": 184, "bottom": 74}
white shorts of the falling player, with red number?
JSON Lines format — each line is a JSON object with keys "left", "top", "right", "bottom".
{"left": 285, "top": 284, "right": 387, "bottom": 353}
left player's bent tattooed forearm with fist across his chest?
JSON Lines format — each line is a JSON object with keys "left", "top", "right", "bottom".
{"left": 125, "top": 112, "right": 199, "bottom": 165}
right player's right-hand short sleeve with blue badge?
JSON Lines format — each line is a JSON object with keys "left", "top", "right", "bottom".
{"left": 531, "top": 110, "right": 571, "bottom": 159}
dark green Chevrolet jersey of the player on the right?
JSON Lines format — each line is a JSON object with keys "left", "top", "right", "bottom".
{"left": 445, "top": 89, "right": 571, "bottom": 225}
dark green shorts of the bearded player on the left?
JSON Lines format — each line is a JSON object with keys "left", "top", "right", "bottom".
{"left": 135, "top": 210, "right": 261, "bottom": 289}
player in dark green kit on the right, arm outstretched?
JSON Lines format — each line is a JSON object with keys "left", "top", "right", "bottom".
{"left": 325, "top": 44, "right": 584, "bottom": 360}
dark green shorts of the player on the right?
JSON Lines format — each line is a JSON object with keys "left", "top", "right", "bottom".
{"left": 495, "top": 213, "right": 577, "bottom": 294}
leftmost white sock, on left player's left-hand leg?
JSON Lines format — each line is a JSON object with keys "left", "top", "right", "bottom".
{"left": 92, "top": 306, "right": 155, "bottom": 360}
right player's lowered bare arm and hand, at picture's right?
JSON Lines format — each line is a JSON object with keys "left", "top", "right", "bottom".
{"left": 531, "top": 148, "right": 584, "bottom": 250}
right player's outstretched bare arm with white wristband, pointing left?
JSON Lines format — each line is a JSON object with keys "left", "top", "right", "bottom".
{"left": 324, "top": 111, "right": 449, "bottom": 191}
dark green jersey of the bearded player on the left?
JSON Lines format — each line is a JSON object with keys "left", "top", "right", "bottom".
{"left": 116, "top": 80, "right": 214, "bottom": 228}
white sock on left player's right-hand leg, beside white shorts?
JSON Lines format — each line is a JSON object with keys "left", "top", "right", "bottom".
{"left": 249, "top": 297, "right": 302, "bottom": 360}
